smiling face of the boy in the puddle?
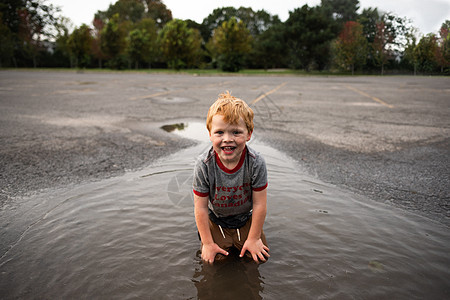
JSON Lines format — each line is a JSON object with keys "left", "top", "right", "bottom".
{"left": 209, "top": 115, "right": 252, "bottom": 168}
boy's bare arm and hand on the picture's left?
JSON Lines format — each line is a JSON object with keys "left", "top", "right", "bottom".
{"left": 194, "top": 194, "right": 228, "bottom": 263}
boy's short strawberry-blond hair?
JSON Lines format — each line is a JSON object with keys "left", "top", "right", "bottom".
{"left": 206, "top": 91, "right": 254, "bottom": 133}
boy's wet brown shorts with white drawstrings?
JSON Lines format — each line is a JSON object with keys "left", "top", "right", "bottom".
{"left": 203, "top": 218, "right": 268, "bottom": 260}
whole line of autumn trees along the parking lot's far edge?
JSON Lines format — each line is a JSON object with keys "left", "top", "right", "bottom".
{"left": 0, "top": 0, "right": 450, "bottom": 74}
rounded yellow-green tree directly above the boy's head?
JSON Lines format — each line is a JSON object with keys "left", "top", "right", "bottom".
{"left": 211, "top": 18, "right": 252, "bottom": 72}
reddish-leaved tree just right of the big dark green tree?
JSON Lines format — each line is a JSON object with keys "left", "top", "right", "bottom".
{"left": 334, "top": 21, "right": 368, "bottom": 75}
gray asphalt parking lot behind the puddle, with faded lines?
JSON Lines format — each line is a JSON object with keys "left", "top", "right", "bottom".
{"left": 0, "top": 70, "right": 450, "bottom": 226}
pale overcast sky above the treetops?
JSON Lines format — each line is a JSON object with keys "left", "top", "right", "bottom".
{"left": 47, "top": 0, "right": 450, "bottom": 34}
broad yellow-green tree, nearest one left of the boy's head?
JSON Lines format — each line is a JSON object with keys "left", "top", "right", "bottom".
{"left": 158, "top": 19, "right": 202, "bottom": 70}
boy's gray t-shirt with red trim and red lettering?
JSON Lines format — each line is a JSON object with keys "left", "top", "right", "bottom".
{"left": 193, "top": 146, "right": 268, "bottom": 228}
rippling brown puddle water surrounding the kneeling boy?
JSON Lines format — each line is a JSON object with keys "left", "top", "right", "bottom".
{"left": 0, "top": 126, "right": 450, "bottom": 299}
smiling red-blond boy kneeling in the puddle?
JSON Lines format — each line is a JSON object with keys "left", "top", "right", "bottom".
{"left": 193, "top": 92, "right": 270, "bottom": 263}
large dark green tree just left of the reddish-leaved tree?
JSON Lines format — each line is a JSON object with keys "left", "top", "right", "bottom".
{"left": 284, "top": 5, "right": 335, "bottom": 71}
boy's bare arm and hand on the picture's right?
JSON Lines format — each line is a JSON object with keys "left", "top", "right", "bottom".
{"left": 240, "top": 189, "right": 270, "bottom": 262}
